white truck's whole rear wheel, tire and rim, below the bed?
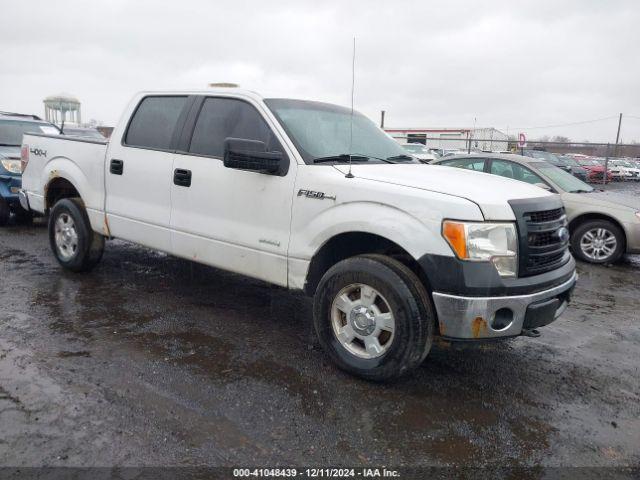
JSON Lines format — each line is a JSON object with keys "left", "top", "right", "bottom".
{"left": 49, "top": 198, "right": 104, "bottom": 272}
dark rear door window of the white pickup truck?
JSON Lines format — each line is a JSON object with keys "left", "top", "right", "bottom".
{"left": 125, "top": 97, "right": 187, "bottom": 150}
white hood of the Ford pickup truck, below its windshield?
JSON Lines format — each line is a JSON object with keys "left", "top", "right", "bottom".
{"left": 336, "top": 164, "right": 552, "bottom": 220}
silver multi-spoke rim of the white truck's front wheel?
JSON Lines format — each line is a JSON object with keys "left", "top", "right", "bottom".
{"left": 331, "top": 283, "right": 396, "bottom": 359}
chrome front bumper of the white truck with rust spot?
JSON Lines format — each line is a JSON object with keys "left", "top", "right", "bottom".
{"left": 433, "top": 272, "right": 578, "bottom": 340}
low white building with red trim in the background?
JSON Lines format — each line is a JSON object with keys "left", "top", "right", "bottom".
{"left": 384, "top": 127, "right": 509, "bottom": 152}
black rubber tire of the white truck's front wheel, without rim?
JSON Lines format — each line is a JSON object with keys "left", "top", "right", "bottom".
{"left": 313, "top": 255, "right": 435, "bottom": 381}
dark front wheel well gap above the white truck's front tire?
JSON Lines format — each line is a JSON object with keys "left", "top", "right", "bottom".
{"left": 304, "top": 232, "right": 431, "bottom": 295}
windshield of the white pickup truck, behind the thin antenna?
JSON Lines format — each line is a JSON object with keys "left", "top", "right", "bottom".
{"left": 265, "top": 98, "right": 418, "bottom": 163}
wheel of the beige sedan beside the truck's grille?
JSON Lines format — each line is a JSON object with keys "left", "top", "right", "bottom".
{"left": 571, "top": 220, "right": 625, "bottom": 263}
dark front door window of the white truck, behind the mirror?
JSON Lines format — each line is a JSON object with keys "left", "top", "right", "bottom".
{"left": 189, "top": 98, "right": 282, "bottom": 157}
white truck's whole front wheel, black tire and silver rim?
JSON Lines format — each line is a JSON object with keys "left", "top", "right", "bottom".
{"left": 314, "top": 255, "right": 435, "bottom": 381}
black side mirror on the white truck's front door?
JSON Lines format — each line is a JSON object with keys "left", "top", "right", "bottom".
{"left": 223, "top": 138, "right": 284, "bottom": 175}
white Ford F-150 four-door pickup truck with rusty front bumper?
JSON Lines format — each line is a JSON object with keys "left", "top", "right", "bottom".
{"left": 20, "top": 89, "right": 576, "bottom": 380}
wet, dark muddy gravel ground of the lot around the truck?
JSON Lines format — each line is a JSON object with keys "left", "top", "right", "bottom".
{"left": 0, "top": 186, "right": 640, "bottom": 466}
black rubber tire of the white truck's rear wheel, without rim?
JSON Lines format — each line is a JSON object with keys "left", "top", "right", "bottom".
{"left": 49, "top": 198, "right": 104, "bottom": 272}
